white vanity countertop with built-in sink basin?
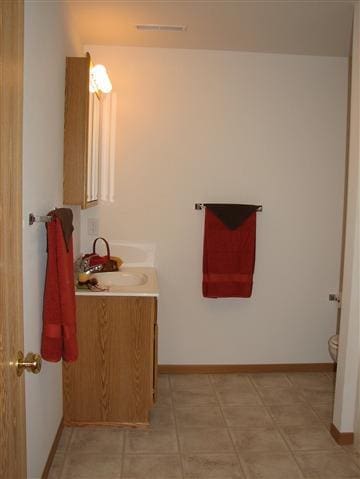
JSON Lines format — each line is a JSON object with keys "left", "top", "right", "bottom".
{"left": 75, "top": 266, "right": 159, "bottom": 297}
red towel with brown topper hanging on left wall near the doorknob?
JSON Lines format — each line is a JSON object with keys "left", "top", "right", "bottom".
{"left": 41, "top": 208, "right": 78, "bottom": 362}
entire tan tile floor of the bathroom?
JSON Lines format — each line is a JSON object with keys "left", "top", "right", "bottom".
{"left": 49, "top": 373, "right": 360, "bottom": 479}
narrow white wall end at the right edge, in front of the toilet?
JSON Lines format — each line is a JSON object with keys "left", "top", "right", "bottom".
{"left": 333, "top": 2, "right": 360, "bottom": 436}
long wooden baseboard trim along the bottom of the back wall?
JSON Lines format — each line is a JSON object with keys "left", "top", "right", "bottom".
{"left": 158, "top": 363, "right": 336, "bottom": 374}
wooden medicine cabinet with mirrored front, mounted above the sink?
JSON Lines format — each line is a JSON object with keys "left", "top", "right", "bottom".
{"left": 63, "top": 53, "right": 101, "bottom": 209}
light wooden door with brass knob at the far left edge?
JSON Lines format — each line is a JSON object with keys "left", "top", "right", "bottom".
{"left": 0, "top": 0, "right": 26, "bottom": 479}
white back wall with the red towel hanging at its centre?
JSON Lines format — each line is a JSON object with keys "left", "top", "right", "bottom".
{"left": 81, "top": 46, "right": 347, "bottom": 364}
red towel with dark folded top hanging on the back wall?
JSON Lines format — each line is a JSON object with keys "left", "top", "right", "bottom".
{"left": 203, "top": 205, "right": 257, "bottom": 298}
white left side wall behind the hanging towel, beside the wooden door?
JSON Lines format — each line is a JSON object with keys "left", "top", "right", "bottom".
{"left": 23, "top": 1, "right": 82, "bottom": 479}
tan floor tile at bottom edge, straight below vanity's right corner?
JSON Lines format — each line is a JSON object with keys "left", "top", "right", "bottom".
{"left": 121, "top": 454, "right": 182, "bottom": 479}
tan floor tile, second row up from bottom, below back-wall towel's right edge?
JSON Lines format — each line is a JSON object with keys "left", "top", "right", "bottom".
{"left": 230, "top": 427, "right": 288, "bottom": 452}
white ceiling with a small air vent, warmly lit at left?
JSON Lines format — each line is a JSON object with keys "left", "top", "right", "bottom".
{"left": 67, "top": 0, "right": 354, "bottom": 56}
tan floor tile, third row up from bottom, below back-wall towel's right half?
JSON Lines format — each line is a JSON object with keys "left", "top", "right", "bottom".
{"left": 223, "top": 406, "right": 273, "bottom": 428}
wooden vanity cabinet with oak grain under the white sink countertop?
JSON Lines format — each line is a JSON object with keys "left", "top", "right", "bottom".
{"left": 63, "top": 296, "right": 157, "bottom": 425}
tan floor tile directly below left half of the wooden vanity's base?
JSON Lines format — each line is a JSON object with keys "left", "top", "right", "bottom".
{"left": 69, "top": 427, "right": 124, "bottom": 455}
